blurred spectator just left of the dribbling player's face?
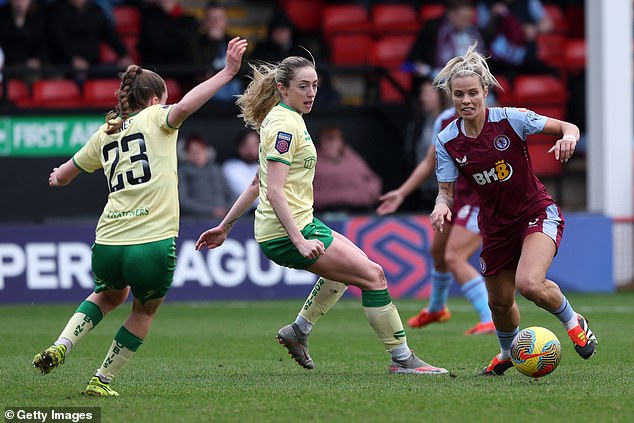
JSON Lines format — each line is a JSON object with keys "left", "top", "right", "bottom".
{"left": 404, "top": 78, "right": 449, "bottom": 211}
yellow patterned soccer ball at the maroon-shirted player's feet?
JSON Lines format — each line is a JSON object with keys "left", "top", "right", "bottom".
{"left": 511, "top": 326, "right": 561, "bottom": 378}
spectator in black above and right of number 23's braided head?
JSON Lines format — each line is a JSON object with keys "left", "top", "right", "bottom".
{"left": 138, "top": 0, "right": 198, "bottom": 70}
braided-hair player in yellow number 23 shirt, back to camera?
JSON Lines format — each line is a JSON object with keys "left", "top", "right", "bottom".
{"left": 33, "top": 37, "right": 247, "bottom": 396}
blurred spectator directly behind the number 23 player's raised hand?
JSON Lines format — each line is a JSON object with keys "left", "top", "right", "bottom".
{"left": 190, "top": 1, "right": 242, "bottom": 102}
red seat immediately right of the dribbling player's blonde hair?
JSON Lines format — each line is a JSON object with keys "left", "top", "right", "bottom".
{"left": 513, "top": 75, "right": 567, "bottom": 108}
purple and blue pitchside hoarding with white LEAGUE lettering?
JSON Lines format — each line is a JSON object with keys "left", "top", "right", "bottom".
{"left": 0, "top": 215, "right": 614, "bottom": 304}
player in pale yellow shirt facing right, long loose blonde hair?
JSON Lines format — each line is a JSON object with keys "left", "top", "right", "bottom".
{"left": 196, "top": 56, "right": 447, "bottom": 374}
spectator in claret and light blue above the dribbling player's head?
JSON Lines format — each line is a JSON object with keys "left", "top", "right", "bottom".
{"left": 478, "top": 0, "right": 556, "bottom": 79}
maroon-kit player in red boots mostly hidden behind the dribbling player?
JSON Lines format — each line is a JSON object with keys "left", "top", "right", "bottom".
{"left": 377, "top": 108, "right": 495, "bottom": 335}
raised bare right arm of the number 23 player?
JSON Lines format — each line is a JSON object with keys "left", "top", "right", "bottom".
{"left": 167, "top": 37, "right": 247, "bottom": 128}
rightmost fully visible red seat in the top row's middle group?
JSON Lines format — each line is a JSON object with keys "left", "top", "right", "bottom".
{"left": 371, "top": 4, "right": 421, "bottom": 36}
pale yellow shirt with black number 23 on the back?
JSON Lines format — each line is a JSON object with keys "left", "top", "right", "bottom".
{"left": 73, "top": 105, "right": 179, "bottom": 245}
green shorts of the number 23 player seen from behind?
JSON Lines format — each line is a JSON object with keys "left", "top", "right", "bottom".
{"left": 92, "top": 237, "right": 176, "bottom": 303}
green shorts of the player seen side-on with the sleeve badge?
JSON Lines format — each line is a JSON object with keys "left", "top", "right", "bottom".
{"left": 259, "top": 218, "right": 334, "bottom": 269}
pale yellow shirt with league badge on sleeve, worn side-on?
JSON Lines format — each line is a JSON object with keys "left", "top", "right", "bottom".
{"left": 255, "top": 103, "right": 317, "bottom": 242}
